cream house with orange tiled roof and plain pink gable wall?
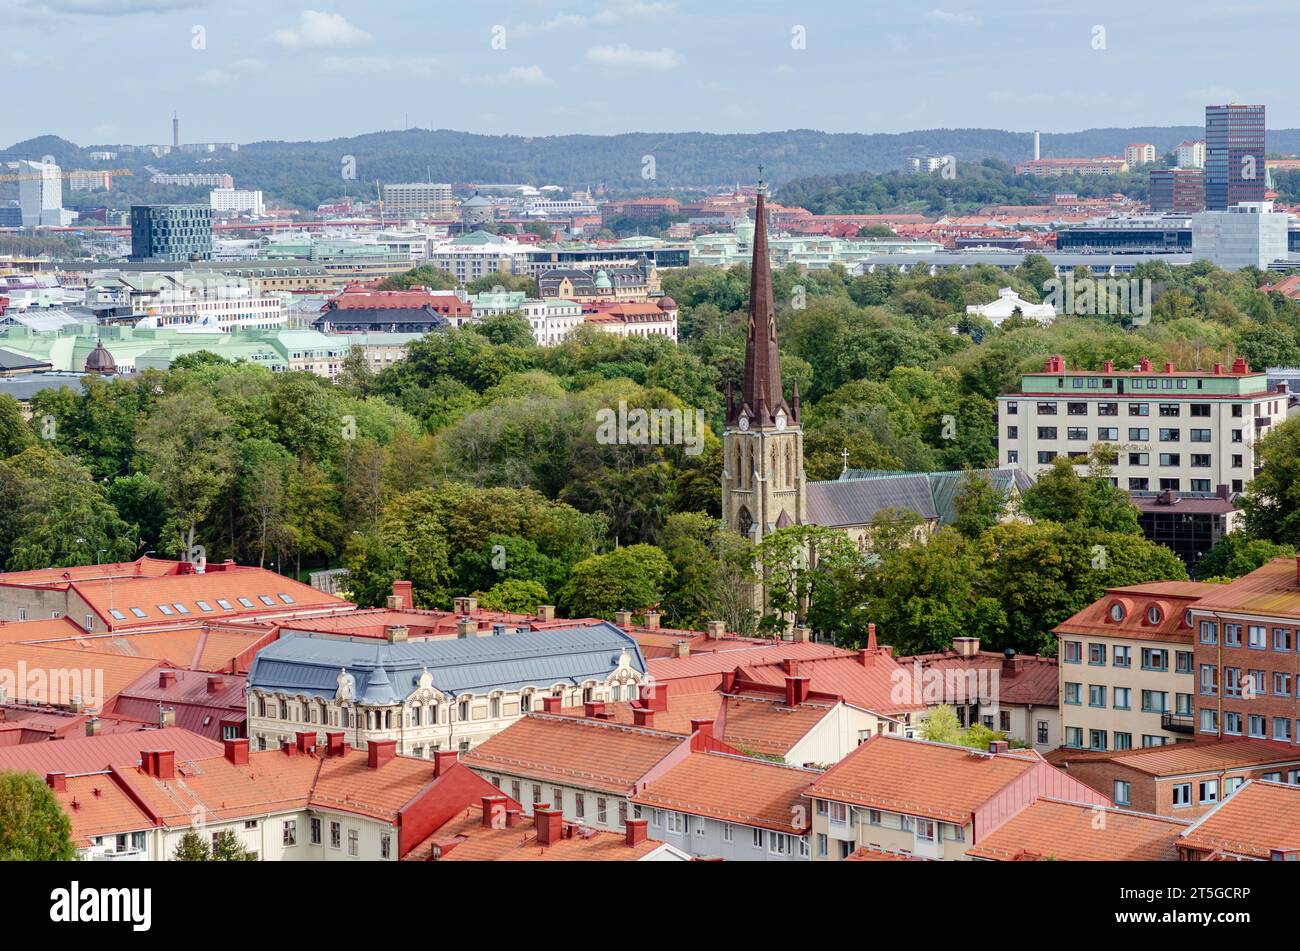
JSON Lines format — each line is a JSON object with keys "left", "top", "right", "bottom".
{"left": 805, "top": 737, "right": 1110, "bottom": 861}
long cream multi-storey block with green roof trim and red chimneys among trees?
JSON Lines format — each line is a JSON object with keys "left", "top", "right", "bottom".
{"left": 997, "top": 356, "right": 1286, "bottom": 501}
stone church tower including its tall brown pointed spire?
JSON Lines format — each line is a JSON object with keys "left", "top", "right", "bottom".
{"left": 723, "top": 174, "right": 806, "bottom": 544}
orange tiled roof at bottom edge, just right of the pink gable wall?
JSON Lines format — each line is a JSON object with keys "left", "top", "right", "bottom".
{"left": 966, "top": 799, "right": 1190, "bottom": 861}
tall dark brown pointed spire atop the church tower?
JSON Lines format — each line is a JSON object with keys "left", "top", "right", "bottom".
{"left": 728, "top": 166, "right": 798, "bottom": 426}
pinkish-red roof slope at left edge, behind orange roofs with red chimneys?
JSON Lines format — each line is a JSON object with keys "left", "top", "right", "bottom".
{"left": 0, "top": 726, "right": 222, "bottom": 776}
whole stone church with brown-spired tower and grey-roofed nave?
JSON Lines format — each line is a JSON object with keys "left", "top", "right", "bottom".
{"left": 722, "top": 182, "right": 1031, "bottom": 561}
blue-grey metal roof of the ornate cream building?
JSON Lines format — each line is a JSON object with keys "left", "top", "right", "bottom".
{"left": 248, "top": 622, "right": 646, "bottom": 704}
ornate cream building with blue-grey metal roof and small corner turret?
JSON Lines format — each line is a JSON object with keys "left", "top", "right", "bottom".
{"left": 247, "top": 622, "right": 647, "bottom": 757}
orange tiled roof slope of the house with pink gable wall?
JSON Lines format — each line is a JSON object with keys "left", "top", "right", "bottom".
{"left": 807, "top": 735, "right": 1041, "bottom": 824}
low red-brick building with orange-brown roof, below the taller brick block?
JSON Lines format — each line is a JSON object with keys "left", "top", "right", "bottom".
{"left": 1052, "top": 739, "right": 1300, "bottom": 818}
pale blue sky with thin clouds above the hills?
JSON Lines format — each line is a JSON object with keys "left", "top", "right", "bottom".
{"left": 0, "top": 0, "right": 1300, "bottom": 147}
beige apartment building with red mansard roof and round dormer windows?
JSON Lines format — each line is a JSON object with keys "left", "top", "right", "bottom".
{"left": 1053, "top": 581, "right": 1218, "bottom": 751}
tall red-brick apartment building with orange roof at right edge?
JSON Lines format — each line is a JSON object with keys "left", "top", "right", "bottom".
{"left": 1188, "top": 559, "right": 1300, "bottom": 743}
